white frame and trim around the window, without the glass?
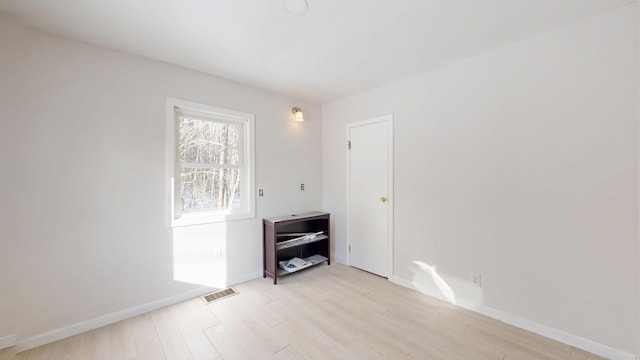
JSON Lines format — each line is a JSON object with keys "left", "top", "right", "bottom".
{"left": 166, "top": 98, "right": 256, "bottom": 227}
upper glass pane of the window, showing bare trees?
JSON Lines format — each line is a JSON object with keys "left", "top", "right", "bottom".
{"left": 178, "top": 116, "right": 241, "bottom": 165}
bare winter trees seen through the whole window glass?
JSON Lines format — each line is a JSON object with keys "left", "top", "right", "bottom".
{"left": 177, "top": 115, "right": 243, "bottom": 213}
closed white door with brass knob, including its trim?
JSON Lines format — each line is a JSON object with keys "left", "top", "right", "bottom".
{"left": 347, "top": 115, "right": 393, "bottom": 277}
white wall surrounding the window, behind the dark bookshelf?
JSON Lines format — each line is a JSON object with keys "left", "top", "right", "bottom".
{"left": 0, "top": 15, "right": 322, "bottom": 342}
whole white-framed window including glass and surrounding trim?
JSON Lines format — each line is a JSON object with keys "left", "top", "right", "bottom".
{"left": 167, "top": 99, "right": 255, "bottom": 226}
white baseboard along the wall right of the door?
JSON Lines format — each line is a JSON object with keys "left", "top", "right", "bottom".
{"left": 389, "top": 275, "right": 638, "bottom": 360}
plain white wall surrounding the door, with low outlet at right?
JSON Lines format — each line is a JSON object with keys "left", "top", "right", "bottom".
{"left": 322, "top": 5, "right": 639, "bottom": 353}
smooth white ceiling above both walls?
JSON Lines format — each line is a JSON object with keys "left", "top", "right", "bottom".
{"left": 0, "top": 0, "right": 634, "bottom": 104}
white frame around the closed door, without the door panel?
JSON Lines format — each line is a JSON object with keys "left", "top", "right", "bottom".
{"left": 345, "top": 113, "right": 395, "bottom": 280}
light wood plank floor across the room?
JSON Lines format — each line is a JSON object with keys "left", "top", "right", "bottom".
{"left": 0, "top": 264, "right": 600, "bottom": 360}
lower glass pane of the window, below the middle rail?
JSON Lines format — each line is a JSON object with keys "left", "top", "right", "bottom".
{"left": 180, "top": 168, "right": 242, "bottom": 213}
